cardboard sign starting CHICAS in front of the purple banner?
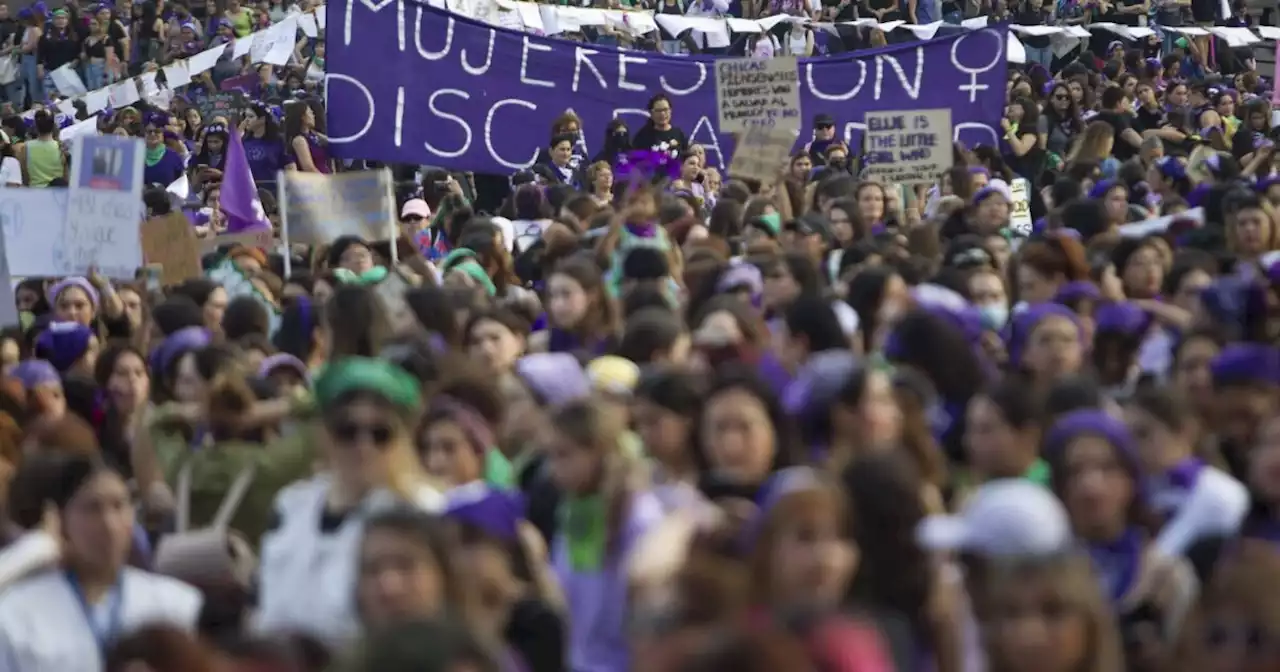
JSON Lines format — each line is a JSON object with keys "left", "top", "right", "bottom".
{"left": 716, "top": 56, "right": 800, "bottom": 133}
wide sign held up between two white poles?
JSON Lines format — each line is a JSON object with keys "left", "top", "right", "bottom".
{"left": 282, "top": 169, "right": 397, "bottom": 244}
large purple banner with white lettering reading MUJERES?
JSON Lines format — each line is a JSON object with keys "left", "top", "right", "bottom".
{"left": 326, "top": 0, "right": 1007, "bottom": 174}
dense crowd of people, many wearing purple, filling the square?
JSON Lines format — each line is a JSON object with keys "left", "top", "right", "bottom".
{"left": 0, "top": 0, "right": 1280, "bottom": 672}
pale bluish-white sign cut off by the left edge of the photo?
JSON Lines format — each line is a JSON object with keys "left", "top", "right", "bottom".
{"left": 0, "top": 187, "right": 68, "bottom": 278}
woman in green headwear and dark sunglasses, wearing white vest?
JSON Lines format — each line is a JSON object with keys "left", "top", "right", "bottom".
{"left": 259, "top": 357, "right": 443, "bottom": 644}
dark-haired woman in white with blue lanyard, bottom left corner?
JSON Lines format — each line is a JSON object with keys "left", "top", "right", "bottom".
{"left": 0, "top": 453, "right": 202, "bottom": 672}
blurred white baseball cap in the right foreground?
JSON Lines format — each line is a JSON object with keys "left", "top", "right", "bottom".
{"left": 915, "top": 479, "right": 1074, "bottom": 558}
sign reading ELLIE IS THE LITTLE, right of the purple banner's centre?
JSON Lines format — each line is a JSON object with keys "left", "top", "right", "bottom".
{"left": 863, "top": 109, "right": 952, "bottom": 184}
